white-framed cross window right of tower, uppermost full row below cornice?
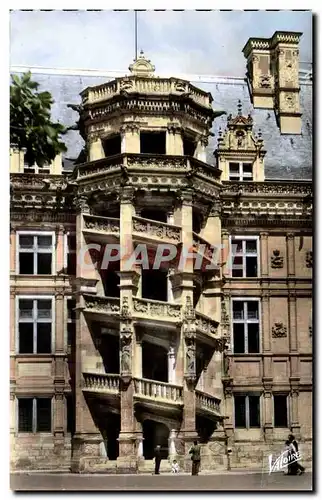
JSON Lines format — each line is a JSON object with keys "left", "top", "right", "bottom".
{"left": 231, "top": 237, "right": 258, "bottom": 278}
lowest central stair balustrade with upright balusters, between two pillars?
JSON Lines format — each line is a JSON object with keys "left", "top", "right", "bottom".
{"left": 134, "top": 378, "right": 183, "bottom": 403}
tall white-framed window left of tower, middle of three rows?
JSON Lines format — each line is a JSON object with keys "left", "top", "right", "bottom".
{"left": 18, "top": 297, "right": 53, "bottom": 354}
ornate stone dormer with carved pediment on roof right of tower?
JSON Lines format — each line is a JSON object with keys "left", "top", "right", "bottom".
{"left": 215, "top": 101, "right": 266, "bottom": 181}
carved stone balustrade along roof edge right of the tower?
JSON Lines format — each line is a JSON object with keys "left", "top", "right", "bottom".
{"left": 221, "top": 180, "right": 313, "bottom": 196}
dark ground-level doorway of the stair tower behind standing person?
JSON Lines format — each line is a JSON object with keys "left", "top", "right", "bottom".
{"left": 143, "top": 420, "right": 169, "bottom": 460}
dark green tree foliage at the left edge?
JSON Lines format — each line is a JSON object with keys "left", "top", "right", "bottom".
{"left": 10, "top": 72, "right": 67, "bottom": 166}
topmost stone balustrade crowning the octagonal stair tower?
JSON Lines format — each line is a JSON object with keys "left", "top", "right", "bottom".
{"left": 81, "top": 77, "right": 211, "bottom": 108}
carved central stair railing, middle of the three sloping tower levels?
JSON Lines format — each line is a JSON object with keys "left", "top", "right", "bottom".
{"left": 133, "top": 298, "right": 181, "bottom": 321}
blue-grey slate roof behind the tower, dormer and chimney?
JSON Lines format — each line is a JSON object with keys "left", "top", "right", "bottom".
{"left": 10, "top": 72, "right": 312, "bottom": 180}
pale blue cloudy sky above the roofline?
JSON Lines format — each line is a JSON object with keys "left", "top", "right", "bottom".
{"left": 10, "top": 10, "right": 312, "bottom": 76}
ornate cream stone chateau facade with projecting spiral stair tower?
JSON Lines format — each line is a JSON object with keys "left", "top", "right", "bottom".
{"left": 10, "top": 32, "right": 313, "bottom": 473}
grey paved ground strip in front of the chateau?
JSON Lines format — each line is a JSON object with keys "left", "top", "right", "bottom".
{"left": 10, "top": 472, "right": 312, "bottom": 491}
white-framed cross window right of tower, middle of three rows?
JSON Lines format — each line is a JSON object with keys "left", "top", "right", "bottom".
{"left": 233, "top": 300, "right": 259, "bottom": 354}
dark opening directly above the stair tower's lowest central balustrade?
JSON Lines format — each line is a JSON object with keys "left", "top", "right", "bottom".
{"left": 142, "top": 342, "right": 169, "bottom": 382}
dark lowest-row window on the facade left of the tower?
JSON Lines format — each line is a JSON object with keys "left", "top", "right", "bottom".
{"left": 18, "top": 398, "right": 51, "bottom": 432}
